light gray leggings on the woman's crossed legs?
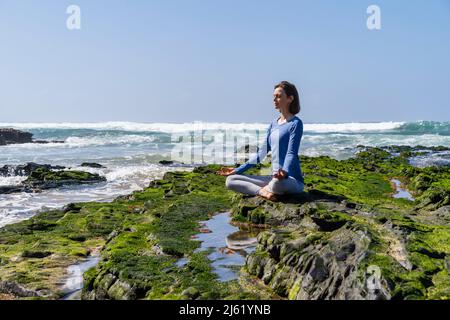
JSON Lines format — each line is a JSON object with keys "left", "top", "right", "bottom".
{"left": 226, "top": 174, "right": 304, "bottom": 196}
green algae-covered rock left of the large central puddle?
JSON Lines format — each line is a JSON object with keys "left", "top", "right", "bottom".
{"left": 0, "top": 166, "right": 258, "bottom": 299}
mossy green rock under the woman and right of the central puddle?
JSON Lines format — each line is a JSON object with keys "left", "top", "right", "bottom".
{"left": 233, "top": 148, "right": 450, "bottom": 299}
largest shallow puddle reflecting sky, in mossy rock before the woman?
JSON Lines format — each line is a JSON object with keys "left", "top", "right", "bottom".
{"left": 185, "top": 212, "right": 263, "bottom": 282}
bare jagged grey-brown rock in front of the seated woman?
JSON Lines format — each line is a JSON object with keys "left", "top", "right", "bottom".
{"left": 235, "top": 198, "right": 392, "bottom": 300}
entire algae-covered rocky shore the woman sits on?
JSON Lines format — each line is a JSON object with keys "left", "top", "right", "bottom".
{"left": 0, "top": 146, "right": 450, "bottom": 300}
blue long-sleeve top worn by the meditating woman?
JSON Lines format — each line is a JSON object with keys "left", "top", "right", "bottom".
{"left": 235, "top": 116, "right": 304, "bottom": 183}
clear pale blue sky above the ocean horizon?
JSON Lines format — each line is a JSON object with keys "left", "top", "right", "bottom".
{"left": 0, "top": 0, "right": 450, "bottom": 123}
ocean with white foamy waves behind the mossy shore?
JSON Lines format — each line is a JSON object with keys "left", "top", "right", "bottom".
{"left": 0, "top": 121, "right": 450, "bottom": 227}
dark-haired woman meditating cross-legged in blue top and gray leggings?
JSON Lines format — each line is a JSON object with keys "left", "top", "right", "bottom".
{"left": 218, "top": 81, "right": 304, "bottom": 201}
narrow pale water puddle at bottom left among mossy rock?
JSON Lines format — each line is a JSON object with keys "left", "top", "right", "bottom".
{"left": 62, "top": 256, "right": 100, "bottom": 300}
